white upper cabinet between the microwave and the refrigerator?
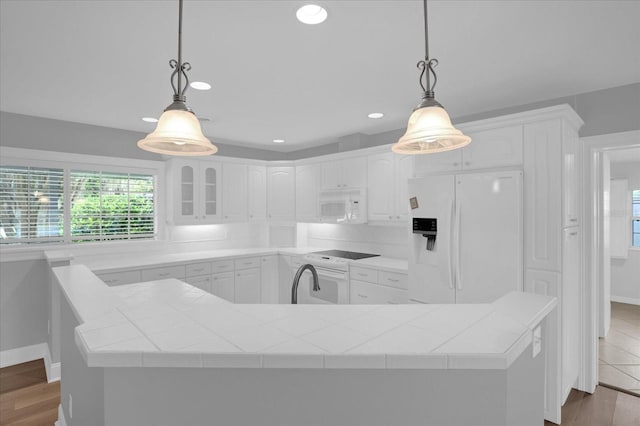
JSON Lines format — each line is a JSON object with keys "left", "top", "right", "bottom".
{"left": 367, "top": 152, "right": 413, "bottom": 223}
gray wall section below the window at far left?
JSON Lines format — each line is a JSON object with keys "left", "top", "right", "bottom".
{"left": 0, "top": 260, "right": 49, "bottom": 351}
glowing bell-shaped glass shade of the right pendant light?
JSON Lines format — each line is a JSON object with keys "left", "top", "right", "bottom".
{"left": 391, "top": 106, "right": 471, "bottom": 154}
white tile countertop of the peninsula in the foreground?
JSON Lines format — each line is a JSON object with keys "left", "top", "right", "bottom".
{"left": 53, "top": 265, "right": 557, "bottom": 369}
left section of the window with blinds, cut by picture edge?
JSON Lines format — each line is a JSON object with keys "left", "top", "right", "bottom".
{"left": 0, "top": 166, "right": 64, "bottom": 243}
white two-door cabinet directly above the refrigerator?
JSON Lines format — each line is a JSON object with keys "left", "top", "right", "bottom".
{"left": 415, "top": 125, "right": 523, "bottom": 174}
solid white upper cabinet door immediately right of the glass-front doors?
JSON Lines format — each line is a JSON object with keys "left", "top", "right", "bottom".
{"left": 222, "top": 163, "right": 247, "bottom": 222}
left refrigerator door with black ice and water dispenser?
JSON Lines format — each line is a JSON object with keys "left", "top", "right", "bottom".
{"left": 409, "top": 176, "right": 455, "bottom": 303}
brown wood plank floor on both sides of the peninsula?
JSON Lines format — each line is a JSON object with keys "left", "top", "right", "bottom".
{"left": 0, "top": 360, "right": 640, "bottom": 426}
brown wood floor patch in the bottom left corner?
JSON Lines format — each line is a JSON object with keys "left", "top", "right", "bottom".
{"left": 0, "top": 359, "right": 60, "bottom": 426}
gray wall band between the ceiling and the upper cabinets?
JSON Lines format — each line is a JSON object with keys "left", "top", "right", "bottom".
{"left": 0, "top": 83, "right": 640, "bottom": 161}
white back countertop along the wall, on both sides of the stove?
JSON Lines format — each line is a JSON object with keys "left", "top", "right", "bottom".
{"left": 60, "top": 247, "right": 408, "bottom": 273}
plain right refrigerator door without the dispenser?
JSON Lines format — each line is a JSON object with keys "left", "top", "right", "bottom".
{"left": 454, "top": 171, "right": 523, "bottom": 303}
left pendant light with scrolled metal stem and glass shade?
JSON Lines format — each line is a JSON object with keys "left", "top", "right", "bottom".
{"left": 138, "top": 0, "right": 218, "bottom": 156}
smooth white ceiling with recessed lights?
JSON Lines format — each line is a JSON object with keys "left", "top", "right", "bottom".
{"left": 0, "top": 0, "right": 640, "bottom": 151}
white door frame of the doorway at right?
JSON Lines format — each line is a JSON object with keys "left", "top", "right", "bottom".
{"left": 578, "top": 130, "right": 640, "bottom": 393}
